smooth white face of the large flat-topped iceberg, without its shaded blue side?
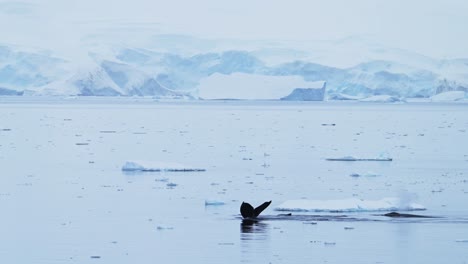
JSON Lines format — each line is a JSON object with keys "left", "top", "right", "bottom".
{"left": 197, "top": 73, "right": 323, "bottom": 100}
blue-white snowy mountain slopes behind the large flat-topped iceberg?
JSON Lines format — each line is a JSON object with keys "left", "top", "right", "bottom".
{"left": 0, "top": 42, "right": 468, "bottom": 98}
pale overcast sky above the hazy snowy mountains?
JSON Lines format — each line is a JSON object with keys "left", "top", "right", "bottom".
{"left": 0, "top": 0, "right": 468, "bottom": 58}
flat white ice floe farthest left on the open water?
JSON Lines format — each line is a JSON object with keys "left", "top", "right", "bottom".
{"left": 122, "top": 161, "right": 206, "bottom": 172}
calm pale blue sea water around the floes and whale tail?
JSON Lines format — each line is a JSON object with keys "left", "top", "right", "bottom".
{"left": 0, "top": 98, "right": 468, "bottom": 263}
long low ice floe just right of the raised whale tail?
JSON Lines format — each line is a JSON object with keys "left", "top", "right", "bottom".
{"left": 275, "top": 197, "right": 426, "bottom": 212}
